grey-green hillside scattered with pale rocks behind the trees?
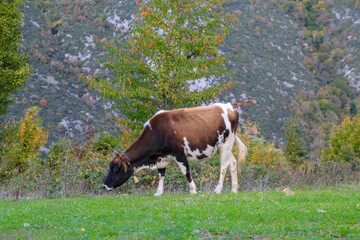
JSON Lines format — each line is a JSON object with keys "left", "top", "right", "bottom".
{"left": 6, "top": 0, "right": 360, "bottom": 146}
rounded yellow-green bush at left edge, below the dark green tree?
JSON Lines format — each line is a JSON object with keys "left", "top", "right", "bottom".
{"left": 0, "top": 107, "right": 48, "bottom": 179}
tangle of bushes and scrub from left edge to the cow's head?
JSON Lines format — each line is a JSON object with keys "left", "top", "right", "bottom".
{"left": 0, "top": 117, "right": 119, "bottom": 197}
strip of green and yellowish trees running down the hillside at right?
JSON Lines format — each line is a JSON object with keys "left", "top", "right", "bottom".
{"left": 282, "top": 0, "right": 358, "bottom": 160}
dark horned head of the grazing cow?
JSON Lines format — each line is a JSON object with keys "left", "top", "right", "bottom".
{"left": 103, "top": 152, "right": 134, "bottom": 191}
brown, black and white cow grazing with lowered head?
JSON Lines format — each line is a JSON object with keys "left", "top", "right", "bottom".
{"left": 103, "top": 103, "right": 247, "bottom": 196}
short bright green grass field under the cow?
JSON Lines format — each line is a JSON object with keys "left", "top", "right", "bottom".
{"left": 0, "top": 188, "right": 360, "bottom": 239}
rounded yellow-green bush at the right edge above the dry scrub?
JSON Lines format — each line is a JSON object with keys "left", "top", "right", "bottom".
{"left": 322, "top": 114, "right": 360, "bottom": 166}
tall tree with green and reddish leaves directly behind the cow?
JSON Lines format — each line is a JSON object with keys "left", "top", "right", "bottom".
{"left": 89, "top": 0, "right": 237, "bottom": 129}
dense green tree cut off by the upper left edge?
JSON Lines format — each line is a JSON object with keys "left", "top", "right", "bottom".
{"left": 0, "top": 0, "right": 31, "bottom": 116}
